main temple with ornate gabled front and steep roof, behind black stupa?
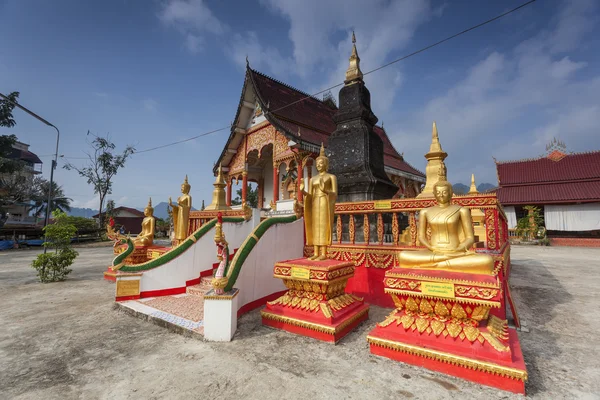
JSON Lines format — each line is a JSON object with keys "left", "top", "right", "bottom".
{"left": 214, "top": 55, "right": 425, "bottom": 210}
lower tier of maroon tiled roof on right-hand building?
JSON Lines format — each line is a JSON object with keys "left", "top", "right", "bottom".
{"left": 496, "top": 179, "right": 600, "bottom": 205}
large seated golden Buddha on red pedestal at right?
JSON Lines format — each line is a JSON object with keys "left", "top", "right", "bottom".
{"left": 399, "top": 179, "right": 494, "bottom": 274}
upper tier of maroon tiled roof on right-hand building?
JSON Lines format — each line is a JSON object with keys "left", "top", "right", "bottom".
{"left": 496, "top": 151, "right": 600, "bottom": 187}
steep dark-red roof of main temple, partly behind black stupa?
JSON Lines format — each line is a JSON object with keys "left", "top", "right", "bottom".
{"left": 217, "top": 66, "right": 425, "bottom": 178}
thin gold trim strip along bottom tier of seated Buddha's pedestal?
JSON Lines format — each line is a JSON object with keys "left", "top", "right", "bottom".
{"left": 367, "top": 335, "right": 527, "bottom": 382}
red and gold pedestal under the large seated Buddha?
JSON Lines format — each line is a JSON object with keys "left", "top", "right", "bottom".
{"left": 367, "top": 268, "right": 527, "bottom": 393}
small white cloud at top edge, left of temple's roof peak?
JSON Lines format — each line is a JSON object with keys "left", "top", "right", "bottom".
{"left": 158, "top": 0, "right": 229, "bottom": 54}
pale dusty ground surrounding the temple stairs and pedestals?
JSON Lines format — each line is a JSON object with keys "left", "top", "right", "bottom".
{"left": 0, "top": 246, "right": 600, "bottom": 400}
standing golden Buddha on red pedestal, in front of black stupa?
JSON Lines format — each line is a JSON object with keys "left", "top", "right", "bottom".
{"left": 300, "top": 144, "right": 337, "bottom": 260}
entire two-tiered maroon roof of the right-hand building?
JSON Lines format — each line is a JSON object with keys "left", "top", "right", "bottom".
{"left": 496, "top": 151, "right": 600, "bottom": 205}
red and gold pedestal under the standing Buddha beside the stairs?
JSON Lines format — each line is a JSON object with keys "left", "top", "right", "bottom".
{"left": 261, "top": 258, "right": 369, "bottom": 343}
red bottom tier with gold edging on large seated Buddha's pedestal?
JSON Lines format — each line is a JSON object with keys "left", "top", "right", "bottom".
{"left": 367, "top": 328, "right": 527, "bottom": 394}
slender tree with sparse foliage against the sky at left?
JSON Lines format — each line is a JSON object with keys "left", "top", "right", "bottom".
{"left": 64, "top": 131, "right": 135, "bottom": 227}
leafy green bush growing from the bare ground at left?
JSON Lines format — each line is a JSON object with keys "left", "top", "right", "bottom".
{"left": 32, "top": 210, "right": 78, "bottom": 283}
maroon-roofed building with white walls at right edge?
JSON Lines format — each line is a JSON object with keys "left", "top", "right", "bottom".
{"left": 496, "top": 140, "right": 600, "bottom": 245}
